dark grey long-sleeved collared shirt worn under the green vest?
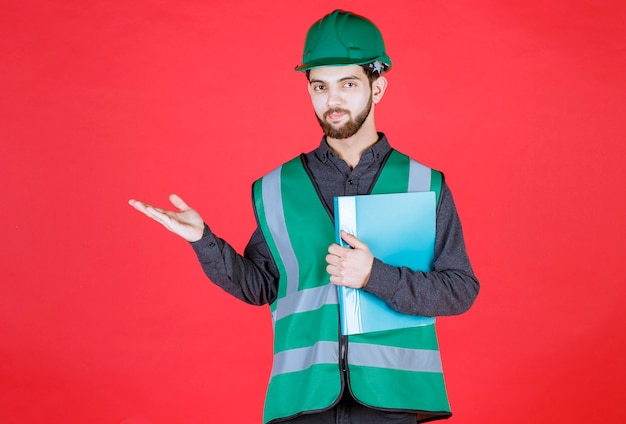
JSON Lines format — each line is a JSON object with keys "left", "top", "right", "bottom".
{"left": 191, "top": 133, "right": 479, "bottom": 316}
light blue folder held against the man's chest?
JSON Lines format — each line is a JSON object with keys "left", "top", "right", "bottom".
{"left": 335, "top": 191, "right": 436, "bottom": 335}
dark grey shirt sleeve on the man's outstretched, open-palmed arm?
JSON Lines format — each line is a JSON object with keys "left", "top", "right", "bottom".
{"left": 191, "top": 226, "right": 278, "bottom": 305}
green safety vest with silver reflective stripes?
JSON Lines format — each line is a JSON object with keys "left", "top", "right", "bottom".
{"left": 253, "top": 150, "right": 451, "bottom": 423}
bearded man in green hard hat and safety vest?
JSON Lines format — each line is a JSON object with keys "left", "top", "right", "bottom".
{"left": 130, "top": 10, "right": 479, "bottom": 423}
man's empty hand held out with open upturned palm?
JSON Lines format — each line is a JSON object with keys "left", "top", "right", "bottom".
{"left": 128, "top": 194, "right": 204, "bottom": 242}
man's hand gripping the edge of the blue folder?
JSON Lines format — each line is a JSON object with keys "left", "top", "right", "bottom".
{"left": 326, "top": 230, "right": 374, "bottom": 289}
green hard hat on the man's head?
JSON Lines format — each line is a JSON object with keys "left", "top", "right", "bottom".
{"left": 296, "top": 10, "right": 391, "bottom": 73}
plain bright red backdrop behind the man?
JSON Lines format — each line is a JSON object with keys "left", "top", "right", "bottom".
{"left": 0, "top": 0, "right": 626, "bottom": 424}
